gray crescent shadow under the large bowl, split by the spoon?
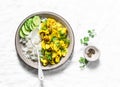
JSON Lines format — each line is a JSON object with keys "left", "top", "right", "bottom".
{"left": 17, "top": 52, "right": 73, "bottom": 77}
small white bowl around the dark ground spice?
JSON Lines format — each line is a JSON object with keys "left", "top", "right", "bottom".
{"left": 84, "top": 46, "right": 100, "bottom": 61}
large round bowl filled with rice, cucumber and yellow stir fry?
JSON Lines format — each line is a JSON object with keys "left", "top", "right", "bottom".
{"left": 15, "top": 12, "right": 74, "bottom": 70}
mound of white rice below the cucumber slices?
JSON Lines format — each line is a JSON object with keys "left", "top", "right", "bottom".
{"left": 20, "top": 31, "right": 41, "bottom": 61}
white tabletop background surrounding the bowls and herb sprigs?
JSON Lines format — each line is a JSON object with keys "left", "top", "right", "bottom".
{"left": 0, "top": 0, "right": 120, "bottom": 87}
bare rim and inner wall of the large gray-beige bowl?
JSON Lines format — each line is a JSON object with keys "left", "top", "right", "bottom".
{"left": 15, "top": 12, "right": 74, "bottom": 70}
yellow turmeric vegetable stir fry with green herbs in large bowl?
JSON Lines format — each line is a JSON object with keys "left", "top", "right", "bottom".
{"left": 39, "top": 18, "right": 70, "bottom": 66}
